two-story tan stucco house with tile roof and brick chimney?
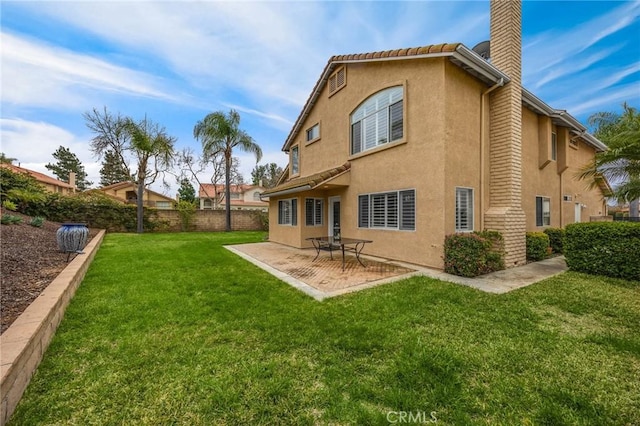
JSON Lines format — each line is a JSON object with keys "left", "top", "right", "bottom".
{"left": 262, "top": 1, "right": 608, "bottom": 268}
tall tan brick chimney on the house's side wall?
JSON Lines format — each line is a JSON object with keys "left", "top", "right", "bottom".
{"left": 485, "top": 0, "right": 526, "bottom": 267}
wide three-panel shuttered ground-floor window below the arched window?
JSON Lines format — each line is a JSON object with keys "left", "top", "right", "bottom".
{"left": 358, "top": 189, "right": 416, "bottom": 231}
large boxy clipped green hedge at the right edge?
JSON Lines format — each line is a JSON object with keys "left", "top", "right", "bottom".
{"left": 564, "top": 222, "right": 640, "bottom": 281}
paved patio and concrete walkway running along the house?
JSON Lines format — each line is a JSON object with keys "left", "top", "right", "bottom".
{"left": 226, "top": 242, "right": 567, "bottom": 300}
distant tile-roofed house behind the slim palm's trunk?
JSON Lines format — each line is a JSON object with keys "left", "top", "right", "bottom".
{"left": 198, "top": 183, "right": 269, "bottom": 212}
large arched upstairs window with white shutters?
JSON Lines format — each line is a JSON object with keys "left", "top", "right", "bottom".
{"left": 351, "top": 86, "right": 404, "bottom": 154}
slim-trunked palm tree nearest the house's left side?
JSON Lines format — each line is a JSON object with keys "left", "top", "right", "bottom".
{"left": 193, "top": 109, "right": 262, "bottom": 231}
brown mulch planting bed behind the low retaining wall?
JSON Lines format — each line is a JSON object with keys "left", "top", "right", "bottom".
{"left": 0, "top": 210, "right": 97, "bottom": 333}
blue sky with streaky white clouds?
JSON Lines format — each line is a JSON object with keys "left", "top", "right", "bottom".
{"left": 0, "top": 0, "right": 640, "bottom": 195}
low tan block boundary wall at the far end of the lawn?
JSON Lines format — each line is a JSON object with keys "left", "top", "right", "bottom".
{"left": 155, "top": 210, "right": 268, "bottom": 232}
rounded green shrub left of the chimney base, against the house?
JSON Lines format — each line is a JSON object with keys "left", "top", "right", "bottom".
{"left": 444, "top": 231, "right": 504, "bottom": 277}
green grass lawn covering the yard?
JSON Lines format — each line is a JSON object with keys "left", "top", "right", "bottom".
{"left": 11, "top": 233, "right": 640, "bottom": 425}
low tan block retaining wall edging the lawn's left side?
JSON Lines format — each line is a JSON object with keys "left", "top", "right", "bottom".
{"left": 0, "top": 230, "right": 105, "bottom": 426}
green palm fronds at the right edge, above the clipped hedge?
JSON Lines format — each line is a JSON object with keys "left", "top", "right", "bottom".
{"left": 581, "top": 103, "right": 640, "bottom": 210}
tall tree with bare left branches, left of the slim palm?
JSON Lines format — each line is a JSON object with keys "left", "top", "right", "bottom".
{"left": 83, "top": 107, "right": 176, "bottom": 233}
